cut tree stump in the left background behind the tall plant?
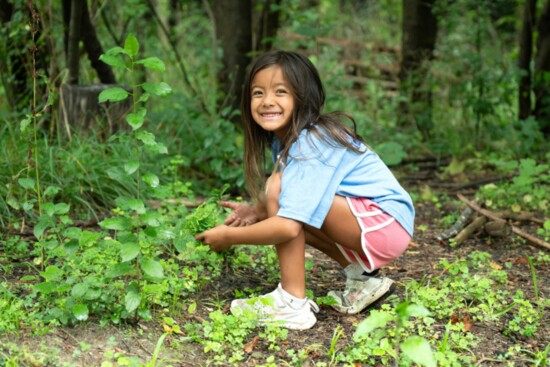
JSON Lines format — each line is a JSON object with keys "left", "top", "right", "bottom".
{"left": 59, "top": 84, "right": 132, "bottom": 139}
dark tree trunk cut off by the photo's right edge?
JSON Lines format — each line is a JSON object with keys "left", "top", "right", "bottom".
{"left": 534, "top": 1, "right": 550, "bottom": 138}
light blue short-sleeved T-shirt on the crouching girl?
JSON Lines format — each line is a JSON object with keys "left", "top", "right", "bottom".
{"left": 272, "top": 129, "right": 414, "bottom": 236}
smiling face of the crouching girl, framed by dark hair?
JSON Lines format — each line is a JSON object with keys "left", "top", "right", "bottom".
{"left": 250, "top": 65, "right": 294, "bottom": 140}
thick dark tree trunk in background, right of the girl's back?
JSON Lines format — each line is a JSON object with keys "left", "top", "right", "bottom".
{"left": 399, "top": 0, "right": 437, "bottom": 140}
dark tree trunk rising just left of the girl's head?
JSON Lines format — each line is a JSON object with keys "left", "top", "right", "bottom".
{"left": 212, "top": 0, "right": 252, "bottom": 122}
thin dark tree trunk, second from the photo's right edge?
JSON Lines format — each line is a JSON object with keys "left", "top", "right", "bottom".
{"left": 518, "top": 0, "right": 537, "bottom": 120}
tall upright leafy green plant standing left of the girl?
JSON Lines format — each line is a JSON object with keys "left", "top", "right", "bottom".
{"left": 98, "top": 35, "right": 172, "bottom": 320}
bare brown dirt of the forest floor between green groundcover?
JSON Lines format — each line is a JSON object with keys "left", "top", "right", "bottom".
{"left": 0, "top": 172, "right": 550, "bottom": 367}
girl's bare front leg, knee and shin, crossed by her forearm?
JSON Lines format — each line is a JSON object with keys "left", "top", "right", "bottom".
{"left": 266, "top": 173, "right": 306, "bottom": 298}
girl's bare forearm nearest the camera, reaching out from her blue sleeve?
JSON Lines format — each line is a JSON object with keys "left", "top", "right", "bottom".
{"left": 195, "top": 216, "right": 303, "bottom": 251}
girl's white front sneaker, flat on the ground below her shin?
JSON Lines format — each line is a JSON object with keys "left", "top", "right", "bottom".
{"left": 231, "top": 284, "right": 319, "bottom": 330}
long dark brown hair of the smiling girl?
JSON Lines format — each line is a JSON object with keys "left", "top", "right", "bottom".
{"left": 241, "top": 51, "right": 363, "bottom": 200}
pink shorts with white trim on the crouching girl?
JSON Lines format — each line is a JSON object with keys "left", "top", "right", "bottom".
{"left": 337, "top": 197, "right": 411, "bottom": 273}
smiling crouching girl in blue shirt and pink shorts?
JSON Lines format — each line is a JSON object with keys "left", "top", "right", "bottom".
{"left": 196, "top": 51, "right": 414, "bottom": 330}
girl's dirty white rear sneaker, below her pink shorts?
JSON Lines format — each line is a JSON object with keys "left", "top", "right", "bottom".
{"left": 328, "top": 264, "right": 393, "bottom": 314}
